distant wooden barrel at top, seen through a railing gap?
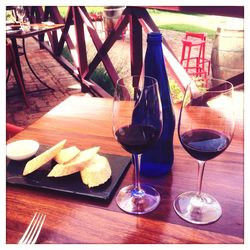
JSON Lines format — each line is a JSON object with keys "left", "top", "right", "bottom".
{"left": 103, "top": 6, "right": 125, "bottom": 38}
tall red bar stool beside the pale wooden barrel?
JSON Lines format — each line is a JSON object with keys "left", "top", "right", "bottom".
{"left": 180, "top": 32, "right": 210, "bottom": 78}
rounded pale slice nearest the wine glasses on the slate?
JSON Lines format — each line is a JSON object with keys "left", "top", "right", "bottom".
{"left": 80, "top": 154, "right": 111, "bottom": 188}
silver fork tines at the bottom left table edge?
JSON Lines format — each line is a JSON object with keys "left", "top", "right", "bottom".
{"left": 18, "top": 212, "right": 46, "bottom": 244}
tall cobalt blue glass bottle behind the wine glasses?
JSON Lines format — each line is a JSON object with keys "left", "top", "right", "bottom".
{"left": 140, "top": 32, "right": 175, "bottom": 176}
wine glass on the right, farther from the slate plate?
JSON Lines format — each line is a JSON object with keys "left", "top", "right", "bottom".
{"left": 173, "top": 78, "right": 235, "bottom": 224}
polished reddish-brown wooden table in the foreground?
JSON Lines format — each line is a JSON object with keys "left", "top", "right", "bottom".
{"left": 6, "top": 96, "right": 244, "bottom": 243}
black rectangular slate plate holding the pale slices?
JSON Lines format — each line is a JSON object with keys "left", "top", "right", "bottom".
{"left": 6, "top": 145, "right": 130, "bottom": 200}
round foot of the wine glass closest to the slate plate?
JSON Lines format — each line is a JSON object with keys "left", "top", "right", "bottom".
{"left": 116, "top": 184, "right": 160, "bottom": 214}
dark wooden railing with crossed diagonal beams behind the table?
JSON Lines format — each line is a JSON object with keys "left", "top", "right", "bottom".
{"left": 23, "top": 6, "right": 244, "bottom": 97}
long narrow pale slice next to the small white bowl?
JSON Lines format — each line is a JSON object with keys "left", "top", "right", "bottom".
{"left": 23, "top": 140, "right": 67, "bottom": 175}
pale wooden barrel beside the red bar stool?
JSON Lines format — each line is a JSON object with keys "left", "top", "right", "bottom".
{"left": 211, "top": 28, "right": 244, "bottom": 80}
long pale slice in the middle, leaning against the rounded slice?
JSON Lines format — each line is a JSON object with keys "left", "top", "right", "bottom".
{"left": 47, "top": 147, "right": 100, "bottom": 177}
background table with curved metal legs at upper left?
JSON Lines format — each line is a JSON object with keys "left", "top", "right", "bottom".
{"left": 6, "top": 23, "right": 64, "bottom": 92}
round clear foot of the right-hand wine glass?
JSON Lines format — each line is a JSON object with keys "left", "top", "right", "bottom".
{"left": 173, "top": 191, "right": 222, "bottom": 225}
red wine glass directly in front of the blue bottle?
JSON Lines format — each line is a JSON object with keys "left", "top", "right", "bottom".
{"left": 113, "top": 76, "right": 162, "bottom": 214}
